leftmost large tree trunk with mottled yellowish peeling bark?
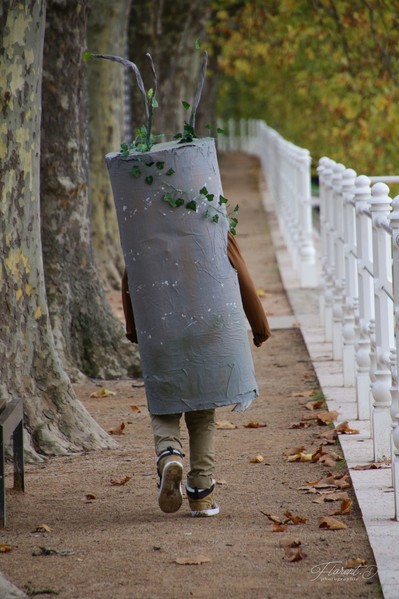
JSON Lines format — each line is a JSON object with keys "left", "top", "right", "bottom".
{"left": 0, "top": 0, "right": 112, "bottom": 459}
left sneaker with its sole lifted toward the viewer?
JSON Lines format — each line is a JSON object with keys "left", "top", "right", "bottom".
{"left": 157, "top": 447, "right": 183, "bottom": 514}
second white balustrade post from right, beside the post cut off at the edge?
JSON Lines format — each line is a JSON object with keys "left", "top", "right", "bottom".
{"left": 370, "top": 183, "right": 394, "bottom": 460}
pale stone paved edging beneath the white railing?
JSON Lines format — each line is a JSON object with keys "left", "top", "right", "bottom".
{"left": 260, "top": 182, "right": 399, "bottom": 599}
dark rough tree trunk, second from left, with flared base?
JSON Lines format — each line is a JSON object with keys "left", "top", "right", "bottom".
{"left": 41, "top": 0, "right": 138, "bottom": 379}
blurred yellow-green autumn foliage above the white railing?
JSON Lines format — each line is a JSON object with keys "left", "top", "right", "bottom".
{"left": 208, "top": 0, "right": 399, "bottom": 175}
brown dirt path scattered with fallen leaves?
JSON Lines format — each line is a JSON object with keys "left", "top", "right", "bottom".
{"left": 0, "top": 154, "right": 382, "bottom": 599}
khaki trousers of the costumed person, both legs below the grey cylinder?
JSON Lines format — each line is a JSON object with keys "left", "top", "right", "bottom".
{"left": 151, "top": 410, "right": 215, "bottom": 489}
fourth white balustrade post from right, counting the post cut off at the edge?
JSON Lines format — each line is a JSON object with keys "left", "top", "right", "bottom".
{"left": 342, "top": 168, "right": 358, "bottom": 387}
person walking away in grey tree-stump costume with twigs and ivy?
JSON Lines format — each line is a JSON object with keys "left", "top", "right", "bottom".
{"left": 91, "top": 49, "right": 270, "bottom": 516}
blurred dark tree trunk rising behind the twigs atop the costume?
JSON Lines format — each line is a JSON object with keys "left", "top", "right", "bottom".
{"left": 129, "top": 0, "right": 210, "bottom": 139}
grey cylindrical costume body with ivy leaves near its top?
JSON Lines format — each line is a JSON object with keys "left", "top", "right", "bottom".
{"left": 106, "top": 138, "right": 258, "bottom": 414}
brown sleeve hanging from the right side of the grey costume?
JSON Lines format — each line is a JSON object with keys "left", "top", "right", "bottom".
{"left": 227, "top": 232, "right": 271, "bottom": 347}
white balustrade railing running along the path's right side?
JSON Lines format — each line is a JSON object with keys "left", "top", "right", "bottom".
{"left": 219, "top": 121, "right": 399, "bottom": 520}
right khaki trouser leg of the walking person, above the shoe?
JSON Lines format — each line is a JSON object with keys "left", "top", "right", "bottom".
{"left": 184, "top": 410, "right": 215, "bottom": 489}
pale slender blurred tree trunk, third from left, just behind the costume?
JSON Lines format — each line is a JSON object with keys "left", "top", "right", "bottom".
{"left": 87, "top": 0, "right": 131, "bottom": 289}
